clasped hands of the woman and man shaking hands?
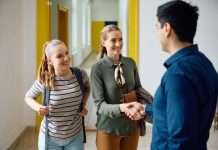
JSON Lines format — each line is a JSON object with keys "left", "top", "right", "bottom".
{"left": 120, "top": 102, "right": 145, "bottom": 120}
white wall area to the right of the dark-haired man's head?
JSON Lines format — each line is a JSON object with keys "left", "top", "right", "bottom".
{"left": 192, "top": 0, "right": 218, "bottom": 71}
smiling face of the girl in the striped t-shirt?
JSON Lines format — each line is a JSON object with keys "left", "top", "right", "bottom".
{"left": 49, "top": 44, "right": 71, "bottom": 73}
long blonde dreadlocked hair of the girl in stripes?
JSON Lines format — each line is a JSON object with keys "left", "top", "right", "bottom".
{"left": 37, "top": 40, "right": 64, "bottom": 89}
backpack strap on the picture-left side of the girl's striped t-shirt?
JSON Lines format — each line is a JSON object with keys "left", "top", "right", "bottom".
{"left": 43, "top": 87, "right": 50, "bottom": 150}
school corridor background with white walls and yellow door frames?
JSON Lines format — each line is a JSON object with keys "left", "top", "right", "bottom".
{"left": 0, "top": 0, "right": 218, "bottom": 150}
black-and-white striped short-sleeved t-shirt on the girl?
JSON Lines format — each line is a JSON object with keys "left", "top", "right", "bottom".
{"left": 26, "top": 70, "right": 89, "bottom": 139}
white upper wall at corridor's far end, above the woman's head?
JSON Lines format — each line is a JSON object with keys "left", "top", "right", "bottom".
{"left": 92, "top": 0, "right": 119, "bottom": 21}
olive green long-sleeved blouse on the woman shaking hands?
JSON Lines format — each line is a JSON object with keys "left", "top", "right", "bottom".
{"left": 91, "top": 56, "right": 141, "bottom": 136}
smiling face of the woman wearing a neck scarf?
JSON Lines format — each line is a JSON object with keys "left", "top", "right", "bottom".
{"left": 102, "top": 31, "right": 123, "bottom": 59}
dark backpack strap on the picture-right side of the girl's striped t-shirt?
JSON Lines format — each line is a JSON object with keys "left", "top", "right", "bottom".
{"left": 70, "top": 67, "right": 86, "bottom": 143}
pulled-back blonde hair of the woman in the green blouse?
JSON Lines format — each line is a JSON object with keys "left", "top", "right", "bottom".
{"left": 99, "top": 24, "right": 121, "bottom": 58}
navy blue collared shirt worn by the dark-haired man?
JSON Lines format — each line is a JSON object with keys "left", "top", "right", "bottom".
{"left": 148, "top": 45, "right": 218, "bottom": 150}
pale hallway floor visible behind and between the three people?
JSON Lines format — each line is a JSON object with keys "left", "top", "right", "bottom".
{"left": 9, "top": 53, "right": 218, "bottom": 150}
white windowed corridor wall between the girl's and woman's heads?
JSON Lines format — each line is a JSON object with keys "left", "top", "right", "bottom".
{"left": 71, "top": 0, "right": 91, "bottom": 66}
